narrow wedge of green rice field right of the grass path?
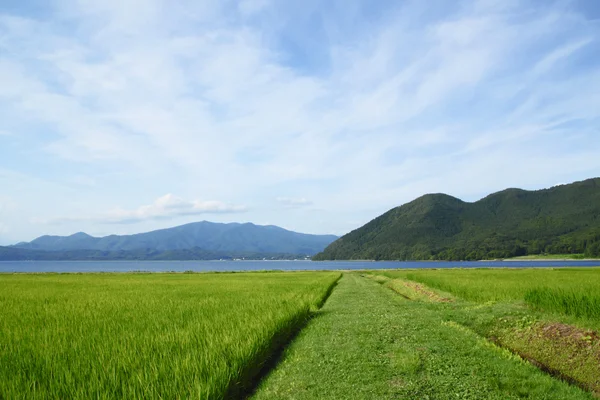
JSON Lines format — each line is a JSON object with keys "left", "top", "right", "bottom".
{"left": 382, "top": 268, "right": 600, "bottom": 322}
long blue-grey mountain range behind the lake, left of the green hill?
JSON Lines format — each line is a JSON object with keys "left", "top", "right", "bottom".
{"left": 0, "top": 221, "right": 337, "bottom": 259}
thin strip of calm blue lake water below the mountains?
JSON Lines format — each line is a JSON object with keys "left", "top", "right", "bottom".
{"left": 0, "top": 260, "right": 600, "bottom": 272}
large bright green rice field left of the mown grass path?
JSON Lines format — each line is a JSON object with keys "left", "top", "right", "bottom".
{"left": 0, "top": 272, "right": 339, "bottom": 399}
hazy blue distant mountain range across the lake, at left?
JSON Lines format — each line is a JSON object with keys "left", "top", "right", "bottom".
{"left": 10, "top": 221, "right": 337, "bottom": 255}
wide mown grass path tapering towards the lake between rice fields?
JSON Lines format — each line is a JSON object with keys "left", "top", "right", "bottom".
{"left": 254, "top": 273, "right": 592, "bottom": 400}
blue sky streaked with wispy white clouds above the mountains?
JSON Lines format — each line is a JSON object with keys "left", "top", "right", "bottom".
{"left": 0, "top": 0, "right": 600, "bottom": 245}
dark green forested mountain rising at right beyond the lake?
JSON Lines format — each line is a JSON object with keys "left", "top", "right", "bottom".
{"left": 313, "top": 178, "right": 600, "bottom": 260}
